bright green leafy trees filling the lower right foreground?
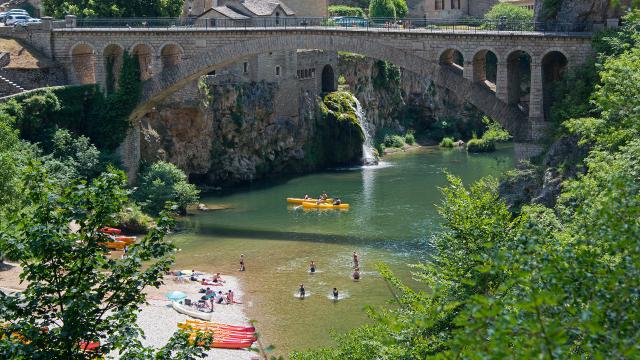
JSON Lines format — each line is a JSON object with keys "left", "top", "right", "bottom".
{"left": 291, "top": 11, "right": 640, "bottom": 360}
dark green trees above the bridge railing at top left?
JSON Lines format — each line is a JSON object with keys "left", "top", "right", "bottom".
{"left": 42, "top": 0, "right": 184, "bottom": 18}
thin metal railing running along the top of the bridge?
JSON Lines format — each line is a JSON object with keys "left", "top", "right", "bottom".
{"left": 67, "top": 17, "right": 593, "bottom": 33}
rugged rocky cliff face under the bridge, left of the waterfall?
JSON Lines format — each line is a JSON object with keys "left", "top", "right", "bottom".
{"left": 141, "top": 82, "right": 362, "bottom": 186}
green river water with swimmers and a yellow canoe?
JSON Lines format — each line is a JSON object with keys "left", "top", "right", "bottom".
{"left": 171, "top": 146, "right": 513, "bottom": 354}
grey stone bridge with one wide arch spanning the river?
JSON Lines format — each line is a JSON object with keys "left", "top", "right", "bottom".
{"left": 10, "top": 24, "right": 593, "bottom": 156}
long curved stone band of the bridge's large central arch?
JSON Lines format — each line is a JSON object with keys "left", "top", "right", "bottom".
{"left": 131, "top": 31, "right": 528, "bottom": 139}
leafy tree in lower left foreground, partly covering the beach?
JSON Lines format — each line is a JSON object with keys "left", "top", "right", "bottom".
{"left": 0, "top": 168, "right": 210, "bottom": 359}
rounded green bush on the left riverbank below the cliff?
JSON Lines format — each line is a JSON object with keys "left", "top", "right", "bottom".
{"left": 134, "top": 161, "right": 200, "bottom": 215}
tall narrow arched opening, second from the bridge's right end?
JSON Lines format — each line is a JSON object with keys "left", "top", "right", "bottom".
{"left": 507, "top": 50, "right": 531, "bottom": 114}
